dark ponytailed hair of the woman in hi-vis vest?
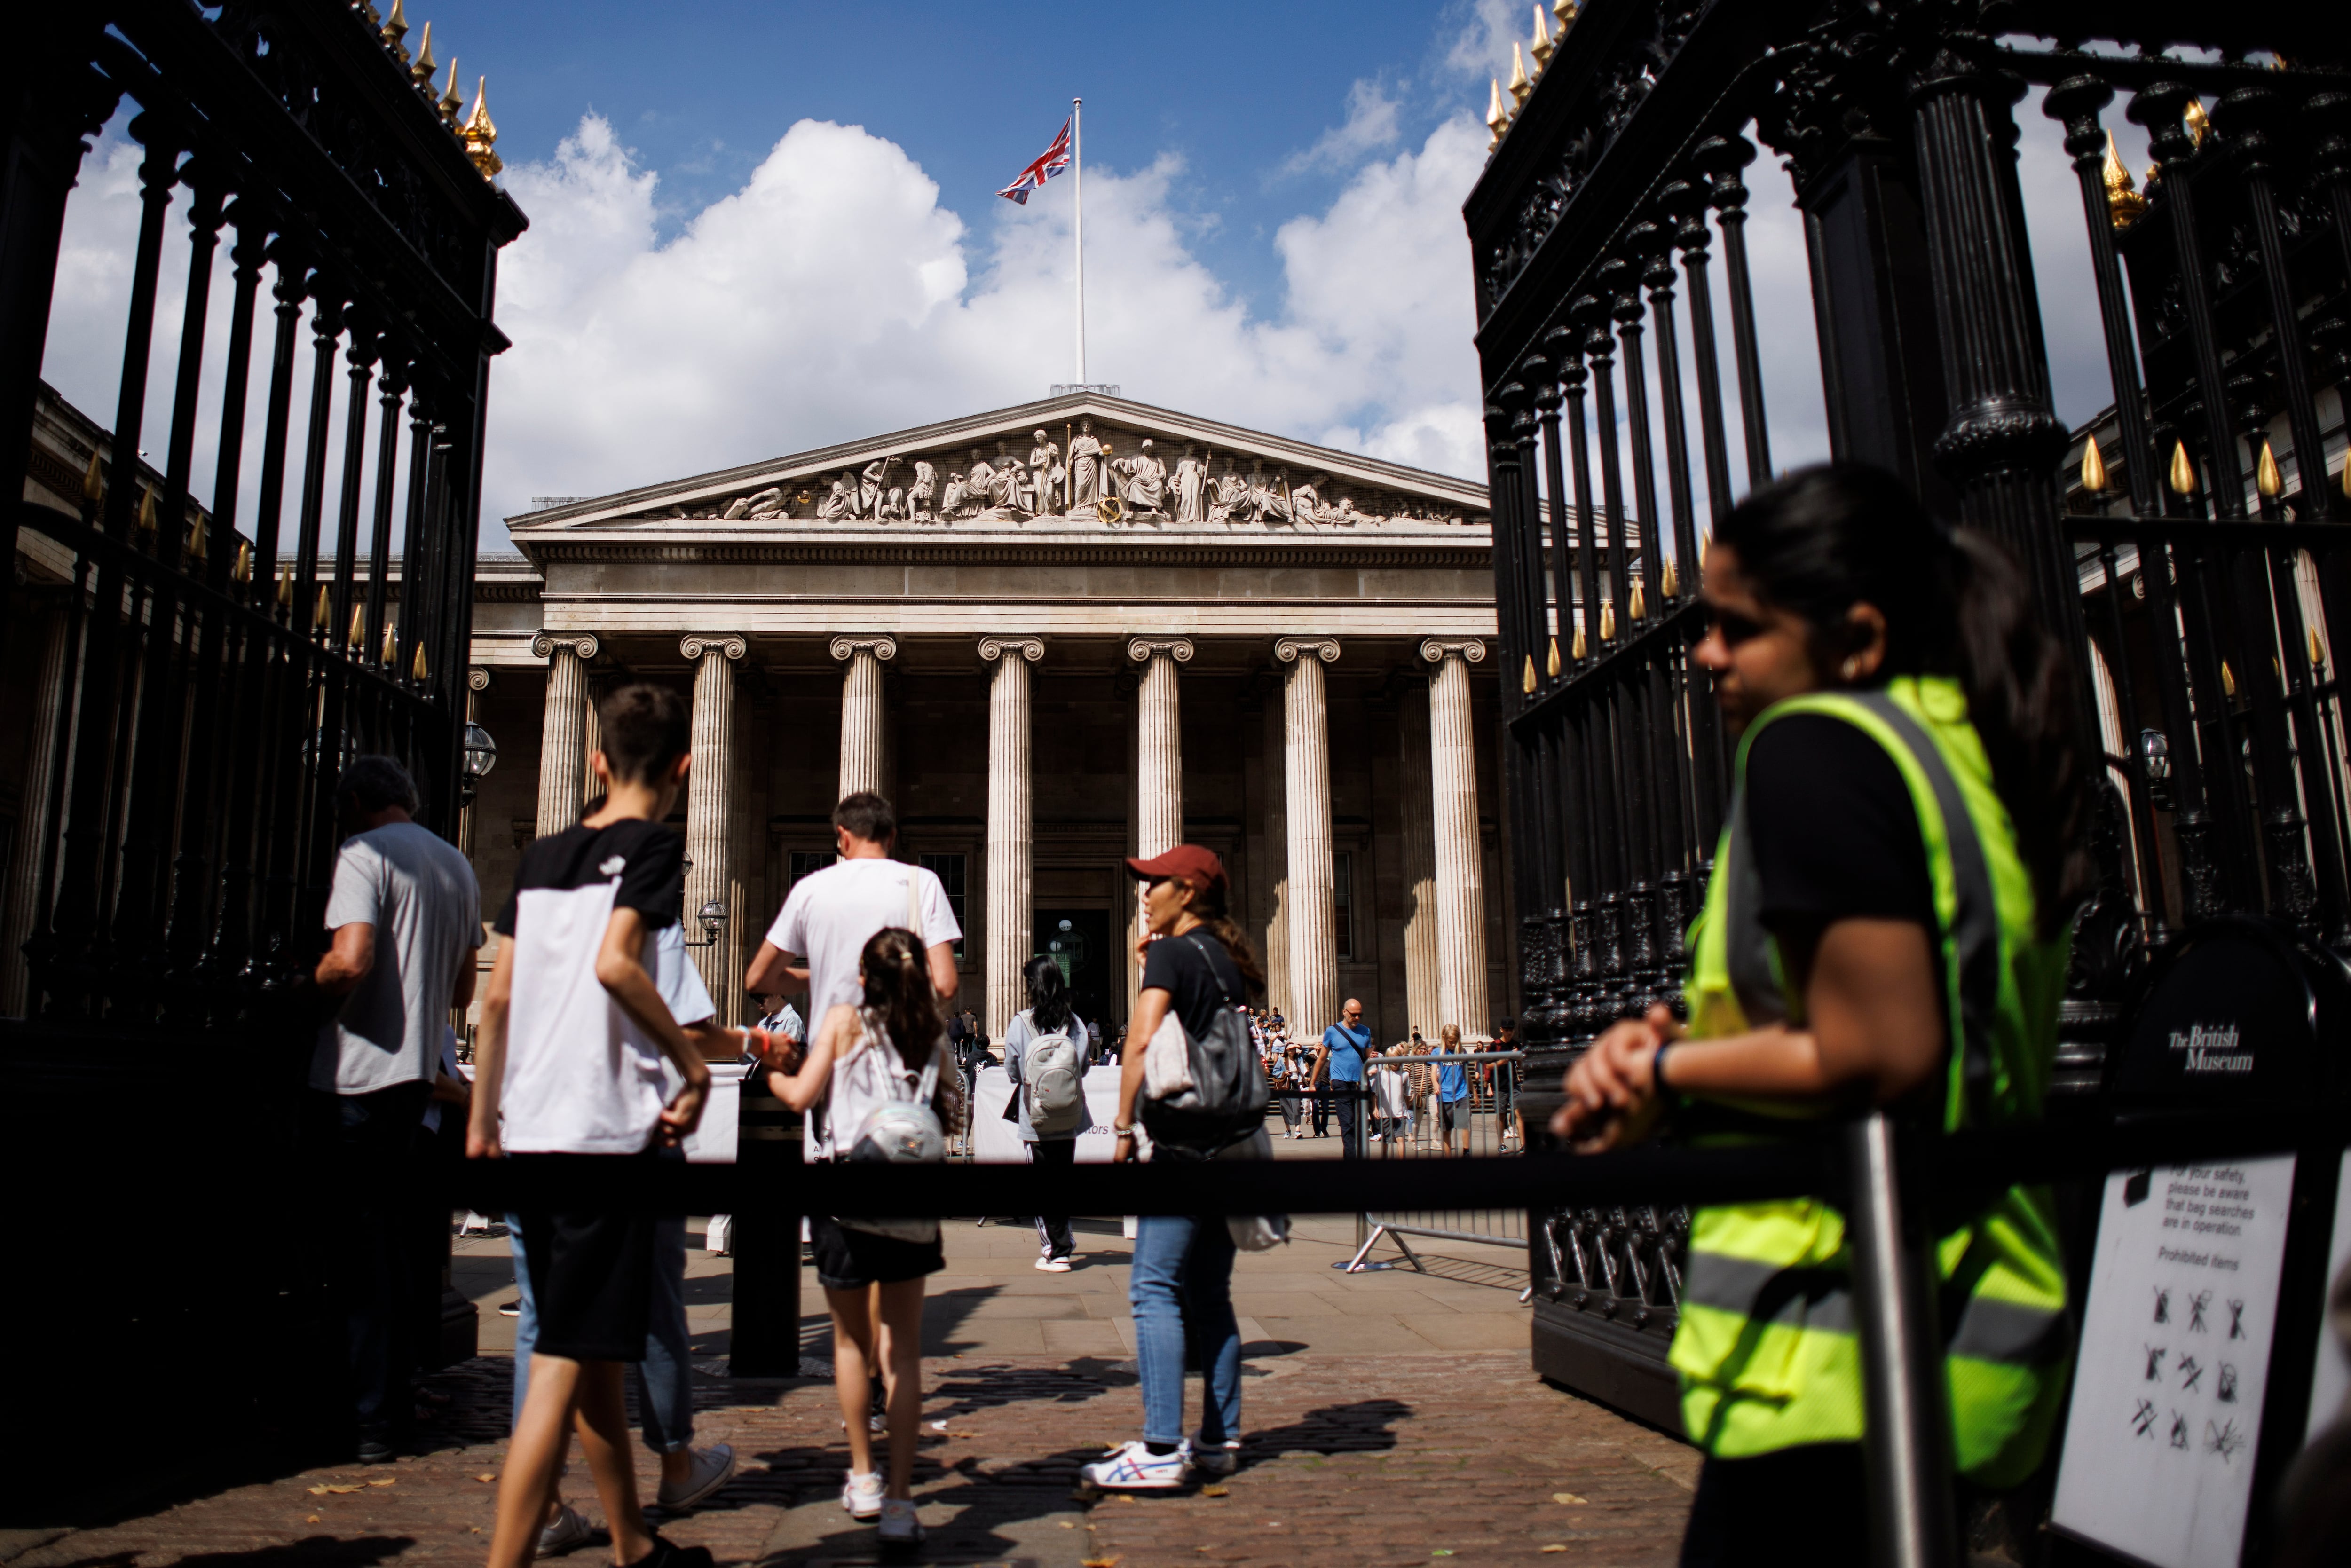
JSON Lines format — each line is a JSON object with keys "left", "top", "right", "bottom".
{"left": 1716, "top": 463, "right": 2090, "bottom": 936}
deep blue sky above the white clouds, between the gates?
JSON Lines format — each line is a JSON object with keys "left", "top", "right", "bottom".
{"left": 442, "top": 0, "right": 1495, "bottom": 320}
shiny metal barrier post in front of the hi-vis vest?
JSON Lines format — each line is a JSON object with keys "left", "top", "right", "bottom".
{"left": 1846, "top": 1112, "right": 1961, "bottom": 1568}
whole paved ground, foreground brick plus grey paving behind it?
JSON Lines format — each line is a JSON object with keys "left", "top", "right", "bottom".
{"left": 0, "top": 1145, "right": 1697, "bottom": 1568}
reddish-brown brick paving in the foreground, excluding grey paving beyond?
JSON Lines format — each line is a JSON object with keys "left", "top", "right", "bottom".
{"left": 0, "top": 1352, "right": 1695, "bottom": 1568}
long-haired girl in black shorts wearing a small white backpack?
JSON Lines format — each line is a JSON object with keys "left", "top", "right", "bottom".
{"left": 769, "top": 926, "right": 962, "bottom": 1544}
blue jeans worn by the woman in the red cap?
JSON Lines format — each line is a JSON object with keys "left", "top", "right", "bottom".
{"left": 1126, "top": 1215, "right": 1241, "bottom": 1443}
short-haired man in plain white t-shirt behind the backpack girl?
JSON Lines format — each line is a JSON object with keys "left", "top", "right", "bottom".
{"left": 743, "top": 790, "right": 964, "bottom": 1018}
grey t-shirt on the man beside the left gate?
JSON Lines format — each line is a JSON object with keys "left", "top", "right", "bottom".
{"left": 310, "top": 823, "right": 482, "bottom": 1095}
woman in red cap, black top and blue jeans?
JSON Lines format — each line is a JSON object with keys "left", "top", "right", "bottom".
{"left": 1084, "top": 844, "right": 1274, "bottom": 1490}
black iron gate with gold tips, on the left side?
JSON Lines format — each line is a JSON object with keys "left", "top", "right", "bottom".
{"left": 0, "top": 0, "right": 522, "bottom": 1483}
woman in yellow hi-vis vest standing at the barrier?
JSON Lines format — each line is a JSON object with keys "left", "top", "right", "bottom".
{"left": 1552, "top": 465, "right": 2088, "bottom": 1563}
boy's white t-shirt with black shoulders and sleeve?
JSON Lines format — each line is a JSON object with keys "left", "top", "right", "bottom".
{"left": 494, "top": 820, "right": 684, "bottom": 1154}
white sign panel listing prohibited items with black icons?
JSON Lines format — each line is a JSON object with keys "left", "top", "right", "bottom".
{"left": 2052, "top": 1154, "right": 2295, "bottom": 1568}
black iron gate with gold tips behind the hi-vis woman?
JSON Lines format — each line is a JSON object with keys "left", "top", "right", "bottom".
{"left": 1465, "top": 0, "right": 2351, "bottom": 1420}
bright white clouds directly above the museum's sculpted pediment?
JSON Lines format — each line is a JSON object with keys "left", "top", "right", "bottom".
{"left": 484, "top": 115, "right": 1481, "bottom": 541}
